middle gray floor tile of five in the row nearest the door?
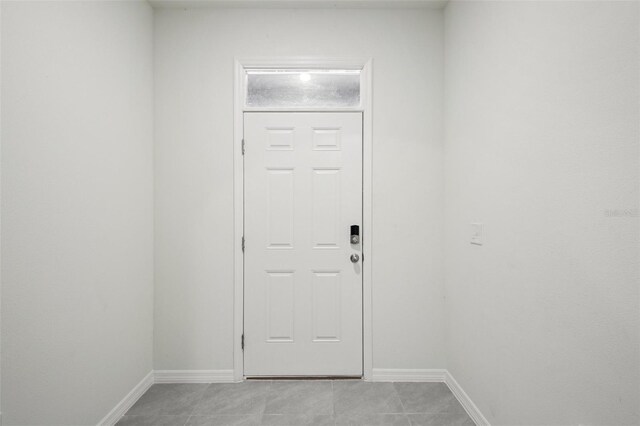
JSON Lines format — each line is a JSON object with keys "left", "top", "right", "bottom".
{"left": 265, "top": 380, "right": 333, "bottom": 414}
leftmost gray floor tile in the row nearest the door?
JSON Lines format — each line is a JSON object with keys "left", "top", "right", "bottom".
{"left": 127, "top": 384, "right": 209, "bottom": 416}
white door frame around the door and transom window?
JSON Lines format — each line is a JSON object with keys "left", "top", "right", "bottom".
{"left": 233, "top": 57, "right": 373, "bottom": 382}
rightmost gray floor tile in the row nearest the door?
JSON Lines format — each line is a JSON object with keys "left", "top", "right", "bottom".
{"left": 393, "top": 383, "right": 460, "bottom": 413}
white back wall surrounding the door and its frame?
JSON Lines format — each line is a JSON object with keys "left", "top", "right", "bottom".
{"left": 155, "top": 9, "right": 444, "bottom": 370}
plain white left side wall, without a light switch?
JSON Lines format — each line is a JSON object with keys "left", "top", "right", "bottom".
{"left": 2, "top": 1, "right": 153, "bottom": 425}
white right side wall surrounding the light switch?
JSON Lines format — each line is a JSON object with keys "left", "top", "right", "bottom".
{"left": 445, "top": 2, "right": 640, "bottom": 425}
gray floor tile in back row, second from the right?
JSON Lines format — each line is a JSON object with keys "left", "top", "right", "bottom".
{"left": 333, "top": 380, "right": 403, "bottom": 414}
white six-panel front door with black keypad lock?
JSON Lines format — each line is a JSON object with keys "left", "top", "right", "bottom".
{"left": 244, "top": 112, "right": 362, "bottom": 376}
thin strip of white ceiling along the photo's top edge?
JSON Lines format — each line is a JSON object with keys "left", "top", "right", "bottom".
{"left": 148, "top": 0, "right": 448, "bottom": 9}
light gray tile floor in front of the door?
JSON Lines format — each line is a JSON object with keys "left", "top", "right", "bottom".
{"left": 118, "top": 380, "right": 474, "bottom": 426}
